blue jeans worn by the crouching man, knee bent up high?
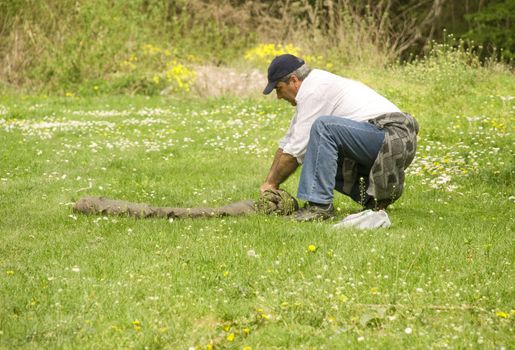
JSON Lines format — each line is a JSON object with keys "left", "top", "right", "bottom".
{"left": 297, "top": 116, "right": 385, "bottom": 204}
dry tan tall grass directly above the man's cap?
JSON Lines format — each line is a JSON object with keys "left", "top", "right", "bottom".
{"left": 248, "top": 0, "right": 398, "bottom": 67}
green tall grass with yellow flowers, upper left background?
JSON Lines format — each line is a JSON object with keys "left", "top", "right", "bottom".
{"left": 0, "top": 0, "right": 254, "bottom": 94}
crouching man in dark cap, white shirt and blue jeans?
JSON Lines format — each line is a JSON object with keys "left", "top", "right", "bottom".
{"left": 260, "top": 54, "right": 418, "bottom": 221}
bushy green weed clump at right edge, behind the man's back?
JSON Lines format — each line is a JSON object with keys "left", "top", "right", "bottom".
{"left": 391, "top": 35, "right": 513, "bottom": 117}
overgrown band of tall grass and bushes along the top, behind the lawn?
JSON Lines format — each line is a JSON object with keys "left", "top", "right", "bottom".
{"left": 0, "top": 0, "right": 515, "bottom": 95}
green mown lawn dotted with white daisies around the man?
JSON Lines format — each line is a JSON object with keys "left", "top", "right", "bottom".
{"left": 0, "top": 62, "right": 515, "bottom": 349}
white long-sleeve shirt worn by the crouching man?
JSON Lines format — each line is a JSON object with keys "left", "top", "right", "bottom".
{"left": 279, "top": 69, "right": 400, "bottom": 164}
